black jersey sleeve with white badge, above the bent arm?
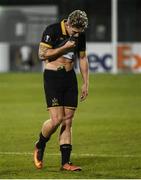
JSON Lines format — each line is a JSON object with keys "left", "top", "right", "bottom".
{"left": 40, "top": 26, "right": 55, "bottom": 48}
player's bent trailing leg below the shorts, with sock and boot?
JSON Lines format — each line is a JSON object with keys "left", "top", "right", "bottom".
{"left": 34, "top": 107, "right": 64, "bottom": 169}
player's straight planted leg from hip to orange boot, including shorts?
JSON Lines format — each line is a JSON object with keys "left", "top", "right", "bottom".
{"left": 59, "top": 70, "right": 81, "bottom": 171}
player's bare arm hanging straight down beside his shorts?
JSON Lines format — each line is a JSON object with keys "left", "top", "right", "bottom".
{"left": 79, "top": 53, "right": 89, "bottom": 101}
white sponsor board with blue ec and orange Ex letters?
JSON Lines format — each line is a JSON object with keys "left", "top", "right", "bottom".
{"left": 82, "top": 43, "right": 141, "bottom": 73}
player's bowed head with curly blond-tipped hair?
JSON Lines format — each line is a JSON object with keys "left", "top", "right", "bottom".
{"left": 67, "top": 10, "right": 88, "bottom": 35}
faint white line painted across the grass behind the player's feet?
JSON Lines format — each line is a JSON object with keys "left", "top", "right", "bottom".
{"left": 0, "top": 152, "right": 141, "bottom": 158}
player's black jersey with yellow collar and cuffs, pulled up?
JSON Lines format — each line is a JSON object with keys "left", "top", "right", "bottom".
{"left": 40, "top": 20, "right": 86, "bottom": 61}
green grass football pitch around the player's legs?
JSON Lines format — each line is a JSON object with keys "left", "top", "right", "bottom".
{"left": 0, "top": 73, "right": 141, "bottom": 179}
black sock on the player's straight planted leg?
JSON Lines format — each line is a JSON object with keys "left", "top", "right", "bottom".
{"left": 60, "top": 144, "right": 72, "bottom": 165}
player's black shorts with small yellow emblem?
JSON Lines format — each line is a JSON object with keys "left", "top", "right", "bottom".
{"left": 44, "top": 68, "right": 78, "bottom": 109}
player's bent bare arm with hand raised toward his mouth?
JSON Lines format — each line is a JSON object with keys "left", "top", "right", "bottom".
{"left": 38, "top": 41, "right": 75, "bottom": 61}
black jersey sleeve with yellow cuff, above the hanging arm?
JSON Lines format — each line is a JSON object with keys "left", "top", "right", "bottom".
{"left": 78, "top": 33, "right": 86, "bottom": 57}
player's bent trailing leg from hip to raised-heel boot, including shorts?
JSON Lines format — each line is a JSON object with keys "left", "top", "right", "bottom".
{"left": 34, "top": 69, "right": 64, "bottom": 168}
